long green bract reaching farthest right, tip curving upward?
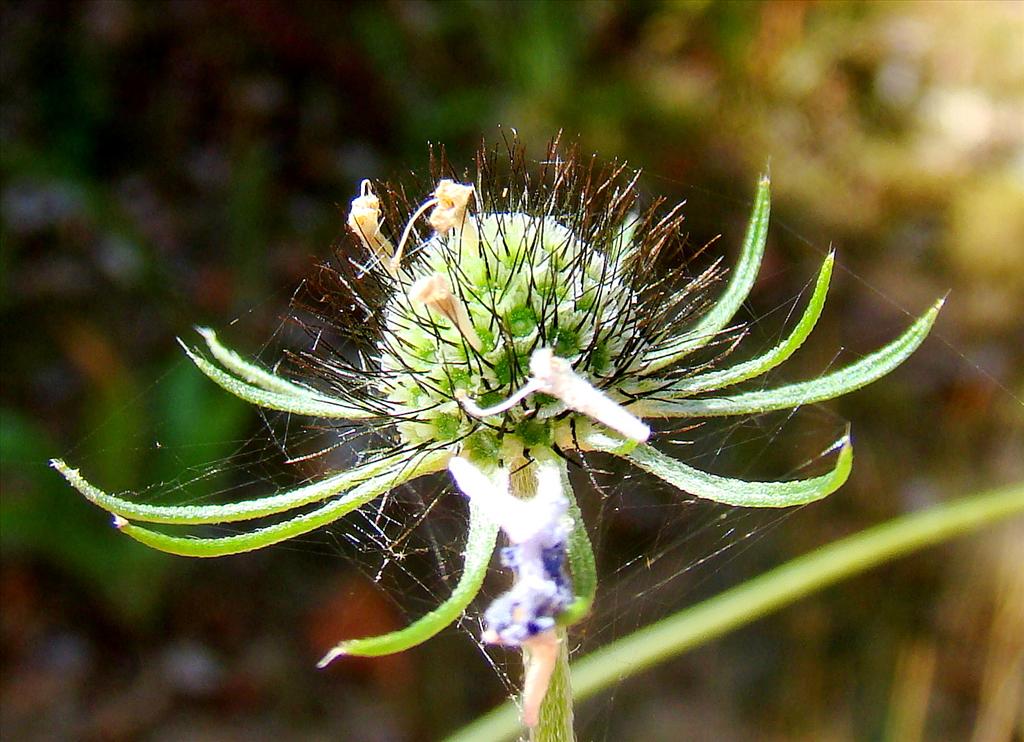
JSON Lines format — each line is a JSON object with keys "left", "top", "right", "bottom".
{"left": 633, "top": 301, "right": 942, "bottom": 418}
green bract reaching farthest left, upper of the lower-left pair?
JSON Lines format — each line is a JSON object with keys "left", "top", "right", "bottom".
{"left": 50, "top": 454, "right": 399, "bottom": 525}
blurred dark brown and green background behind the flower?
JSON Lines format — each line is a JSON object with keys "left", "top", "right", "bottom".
{"left": 0, "top": 0, "right": 1024, "bottom": 740}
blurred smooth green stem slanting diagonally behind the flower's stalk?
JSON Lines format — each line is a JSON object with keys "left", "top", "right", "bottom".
{"left": 449, "top": 483, "right": 1024, "bottom": 742}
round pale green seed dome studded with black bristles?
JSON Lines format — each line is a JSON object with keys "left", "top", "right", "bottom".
{"left": 381, "top": 212, "right": 637, "bottom": 447}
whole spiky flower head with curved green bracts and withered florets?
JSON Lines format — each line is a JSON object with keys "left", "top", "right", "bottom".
{"left": 53, "top": 136, "right": 941, "bottom": 723}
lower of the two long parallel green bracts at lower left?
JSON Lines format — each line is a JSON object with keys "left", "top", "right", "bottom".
{"left": 117, "top": 450, "right": 450, "bottom": 557}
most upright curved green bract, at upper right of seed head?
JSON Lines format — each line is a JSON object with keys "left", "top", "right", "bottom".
{"left": 640, "top": 174, "right": 771, "bottom": 376}
